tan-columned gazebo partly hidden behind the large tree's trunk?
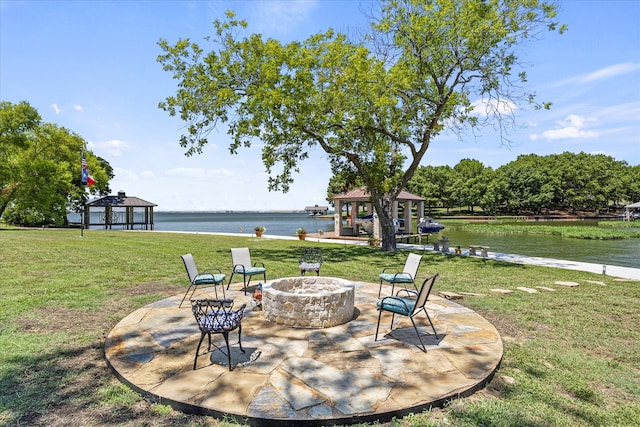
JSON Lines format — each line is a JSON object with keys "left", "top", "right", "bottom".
{"left": 331, "top": 187, "right": 425, "bottom": 238}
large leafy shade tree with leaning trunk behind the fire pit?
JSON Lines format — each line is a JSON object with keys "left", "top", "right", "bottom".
{"left": 158, "top": 0, "right": 560, "bottom": 250}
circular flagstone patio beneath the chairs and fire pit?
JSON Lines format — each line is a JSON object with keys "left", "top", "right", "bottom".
{"left": 105, "top": 282, "right": 503, "bottom": 426}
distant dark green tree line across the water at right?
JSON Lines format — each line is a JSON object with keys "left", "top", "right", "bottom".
{"left": 407, "top": 152, "right": 640, "bottom": 215}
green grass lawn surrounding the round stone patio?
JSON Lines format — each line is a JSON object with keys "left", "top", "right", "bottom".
{"left": 0, "top": 228, "right": 640, "bottom": 426}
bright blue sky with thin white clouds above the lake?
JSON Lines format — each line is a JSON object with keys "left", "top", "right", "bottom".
{"left": 0, "top": 0, "right": 640, "bottom": 211}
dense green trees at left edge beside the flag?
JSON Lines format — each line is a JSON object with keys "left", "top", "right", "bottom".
{"left": 0, "top": 101, "right": 114, "bottom": 226}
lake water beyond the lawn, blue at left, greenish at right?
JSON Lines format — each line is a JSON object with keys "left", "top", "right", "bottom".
{"left": 74, "top": 212, "right": 640, "bottom": 268}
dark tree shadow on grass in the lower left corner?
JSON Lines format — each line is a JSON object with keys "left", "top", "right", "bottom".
{"left": 0, "top": 335, "right": 210, "bottom": 426}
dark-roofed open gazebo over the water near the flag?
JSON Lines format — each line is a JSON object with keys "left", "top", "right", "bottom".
{"left": 84, "top": 191, "right": 158, "bottom": 230}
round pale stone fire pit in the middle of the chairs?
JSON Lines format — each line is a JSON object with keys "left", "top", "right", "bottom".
{"left": 262, "top": 277, "right": 354, "bottom": 328}
